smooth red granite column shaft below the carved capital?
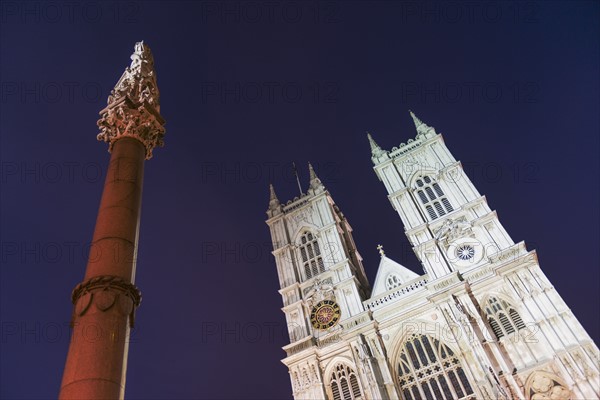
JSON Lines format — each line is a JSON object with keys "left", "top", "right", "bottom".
{"left": 59, "top": 137, "right": 145, "bottom": 399}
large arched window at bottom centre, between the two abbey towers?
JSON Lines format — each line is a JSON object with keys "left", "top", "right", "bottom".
{"left": 398, "top": 335, "right": 475, "bottom": 400}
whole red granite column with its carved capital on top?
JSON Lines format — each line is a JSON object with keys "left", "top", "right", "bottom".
{"left": 59, "top": 43, "right": 164, "bottom": 399}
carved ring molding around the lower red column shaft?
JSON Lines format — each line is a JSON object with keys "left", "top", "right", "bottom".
{"left": 71, "top": 275, "right": 142, "bottom": 328}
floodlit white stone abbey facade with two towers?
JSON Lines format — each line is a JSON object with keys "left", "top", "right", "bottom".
{"left": 267, "top": 113, "right": 600, "bottom": 400}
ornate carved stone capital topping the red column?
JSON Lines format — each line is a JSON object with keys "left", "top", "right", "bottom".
{"left": 97, "top": 42, "right": 165, "bottom": 160}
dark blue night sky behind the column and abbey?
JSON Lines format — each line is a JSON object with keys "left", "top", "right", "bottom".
{"left": 0, "top": 1, "right": 600, "bottom": 399}
